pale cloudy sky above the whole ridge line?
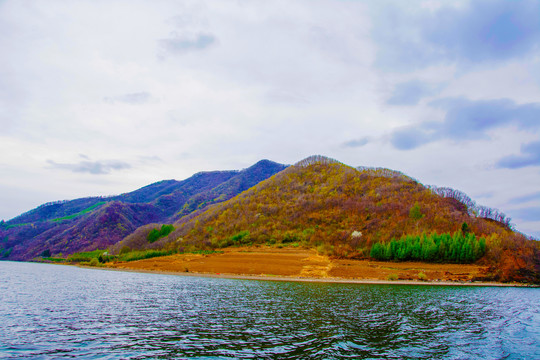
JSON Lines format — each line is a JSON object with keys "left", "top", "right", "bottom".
{"left": 0, "top": 0, "right": 540, "bottom": 237}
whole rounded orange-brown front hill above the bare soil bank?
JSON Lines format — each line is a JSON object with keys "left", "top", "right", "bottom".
{"left": 117, "top": 157, "right": 540, "bottom": 282}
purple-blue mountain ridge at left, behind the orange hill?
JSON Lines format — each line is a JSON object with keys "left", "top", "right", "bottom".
{"left": 0, "top": 160, "right": 286, "bottom": 260}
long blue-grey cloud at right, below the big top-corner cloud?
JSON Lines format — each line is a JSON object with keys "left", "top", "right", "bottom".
{"left": 391, "top": 98, "right": 540, "bottom": 150}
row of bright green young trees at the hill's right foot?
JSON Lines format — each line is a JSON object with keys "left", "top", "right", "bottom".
{"left": 369, "top": 231, "right": 486, "bottom": 264}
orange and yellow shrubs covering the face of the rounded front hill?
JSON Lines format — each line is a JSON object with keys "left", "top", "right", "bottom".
{"left": 165, "top": 161, "right": 486, "bottom": 257}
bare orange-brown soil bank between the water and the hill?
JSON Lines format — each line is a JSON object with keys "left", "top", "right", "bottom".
{"left": 108, "top": 247, "right": 494, "bottom": 282}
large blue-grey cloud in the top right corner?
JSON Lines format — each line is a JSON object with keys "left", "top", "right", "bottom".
{"left": 373, "top": 0, "right": 540, "bottom": 70}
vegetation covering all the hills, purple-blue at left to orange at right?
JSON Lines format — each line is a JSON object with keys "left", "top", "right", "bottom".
{"left": 0, "top": 156, "right": 540, "bottom": 282}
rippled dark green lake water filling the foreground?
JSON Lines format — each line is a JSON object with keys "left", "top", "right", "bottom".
{"left": 0, "top": 262, "right": 540, "bottom": 359}
